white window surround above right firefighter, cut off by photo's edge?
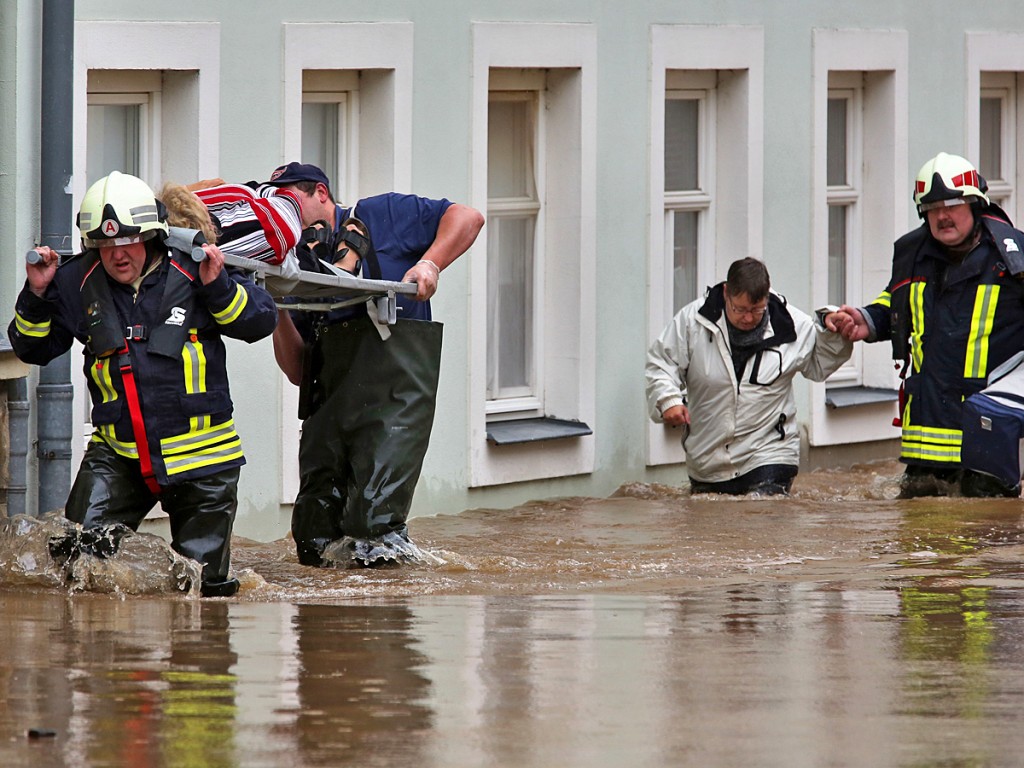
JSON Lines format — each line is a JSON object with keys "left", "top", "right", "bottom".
{"left": 964, "top": 32, "right": 1024, "bottom": 222}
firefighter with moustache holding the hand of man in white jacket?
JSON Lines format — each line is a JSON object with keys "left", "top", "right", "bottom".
{"left": 826, "top": 153, "right": 1024, "bottom": 498}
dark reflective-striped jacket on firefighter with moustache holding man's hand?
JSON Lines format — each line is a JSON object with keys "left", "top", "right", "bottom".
{"left": 865, "top": 215, "right": 1024, "bottom": 468}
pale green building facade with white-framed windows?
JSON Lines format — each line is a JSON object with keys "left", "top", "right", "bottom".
{"left": 0, "top": 0, "right": 1024, "bottom": 540}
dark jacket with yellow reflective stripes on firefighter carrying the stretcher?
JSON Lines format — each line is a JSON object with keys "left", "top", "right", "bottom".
{"left": 8, "top": 240, "right": 278, "bottom": 485}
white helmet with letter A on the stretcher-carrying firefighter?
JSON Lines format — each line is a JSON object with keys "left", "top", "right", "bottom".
{"left": 75, "top": 171, "right": 167, "bottom": 248}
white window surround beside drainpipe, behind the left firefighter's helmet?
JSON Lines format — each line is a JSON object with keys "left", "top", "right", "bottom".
{"left": 71, "top": 22, "right": 220, "bottom": 472}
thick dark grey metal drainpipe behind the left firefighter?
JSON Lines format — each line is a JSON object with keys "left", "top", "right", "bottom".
{"left": 36, "top": 0, "right": 75, "bottom": 515}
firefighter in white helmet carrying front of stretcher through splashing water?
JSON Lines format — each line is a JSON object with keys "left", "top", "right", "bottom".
{"left": 9, "top": 172, "right": 278, "bottom": 596}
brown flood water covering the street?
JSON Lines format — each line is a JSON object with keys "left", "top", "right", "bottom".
{"left": 0, "top": 463, "right": 1024, "bottom": 768}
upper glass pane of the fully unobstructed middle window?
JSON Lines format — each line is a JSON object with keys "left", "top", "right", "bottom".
{"left": 487, "top": 100, "right": 537, "bottom": 200}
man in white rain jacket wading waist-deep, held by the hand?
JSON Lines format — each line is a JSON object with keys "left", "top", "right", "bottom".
{"left": 646, "top": 258, "right": 852, "bottom": 495}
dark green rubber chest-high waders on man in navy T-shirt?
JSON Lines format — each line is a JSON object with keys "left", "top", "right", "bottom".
{"left": 292, "top": 316, "right": 442, "bottom": 565}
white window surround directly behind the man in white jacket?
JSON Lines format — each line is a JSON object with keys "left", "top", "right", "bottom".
{"left": 639, "top": 25, "right": 764, "bottom": 466}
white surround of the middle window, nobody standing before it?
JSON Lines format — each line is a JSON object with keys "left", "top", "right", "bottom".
{"left": 467, "top": 23, "right": 598, "bottom": 487}
